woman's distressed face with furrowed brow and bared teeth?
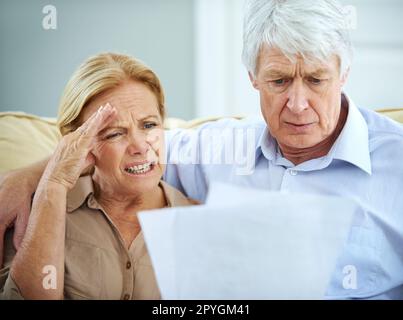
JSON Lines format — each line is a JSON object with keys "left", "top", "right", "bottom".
{"left": 80, "top": 81, "right": 164, "bottom": 196}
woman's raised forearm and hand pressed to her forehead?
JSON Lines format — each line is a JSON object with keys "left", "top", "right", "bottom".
{"left": 10, "top": 107, "right": 116, "bottom": 299}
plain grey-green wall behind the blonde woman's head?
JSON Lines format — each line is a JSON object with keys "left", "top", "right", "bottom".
{"left": 0, "top": 0, "right": 194, "bottom": 119}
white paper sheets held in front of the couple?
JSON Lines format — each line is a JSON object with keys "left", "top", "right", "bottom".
{"left": 139, "top": 184, "right": 360, "bottom": 299}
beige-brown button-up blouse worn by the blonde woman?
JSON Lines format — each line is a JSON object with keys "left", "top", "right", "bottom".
{"left": 0, "top": 176, "right": 196, "bottom": 300}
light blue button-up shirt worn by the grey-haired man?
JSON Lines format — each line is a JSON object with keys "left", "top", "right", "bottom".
{"left": 164, "top": 95, "right": 403, "bottom": 299}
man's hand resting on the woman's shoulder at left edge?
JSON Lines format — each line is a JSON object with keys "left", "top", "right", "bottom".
{"left": 0, "top": 158, "right": 49, "bottom": 266}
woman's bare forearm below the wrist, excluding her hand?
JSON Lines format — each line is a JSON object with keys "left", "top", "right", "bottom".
{"left": 10, "top": 179, "right": 67, "bottom": 299}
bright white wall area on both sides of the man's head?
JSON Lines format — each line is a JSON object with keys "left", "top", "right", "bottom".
{"left": 194, "top": 0, "right": 403, "bottom": 116}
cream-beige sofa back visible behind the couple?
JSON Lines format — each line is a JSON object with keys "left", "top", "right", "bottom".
{"left": 0, "top": 109, "right": 403, "bottom": 174}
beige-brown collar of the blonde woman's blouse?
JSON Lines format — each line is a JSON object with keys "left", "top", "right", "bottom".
{"left": 67, "top": 175, "right": 196, "bottom": 213}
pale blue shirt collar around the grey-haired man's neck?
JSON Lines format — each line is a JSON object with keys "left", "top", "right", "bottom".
{"left": 256, "top": 93, "right": 372, "bottom": 174}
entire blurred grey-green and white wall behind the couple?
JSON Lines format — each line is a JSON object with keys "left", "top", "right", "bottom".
{"left": 0, "top": 0, "right": 403, "bottom": 120}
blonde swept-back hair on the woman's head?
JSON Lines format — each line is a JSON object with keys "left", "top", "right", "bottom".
{"left": 57, "top": 53, "right": 165, "bottom": 135}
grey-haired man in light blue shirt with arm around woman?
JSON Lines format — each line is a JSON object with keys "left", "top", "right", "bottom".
{"left": 0, "top": 0, "right": 403, "bottom": 299}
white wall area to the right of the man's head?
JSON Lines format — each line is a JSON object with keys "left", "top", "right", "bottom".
{"left": 344, "top": 0, "right": 403, "bottom": 109}
